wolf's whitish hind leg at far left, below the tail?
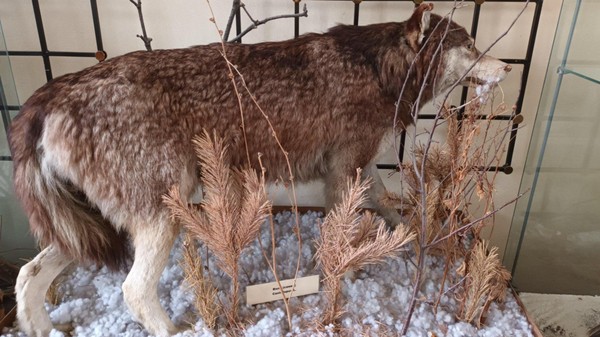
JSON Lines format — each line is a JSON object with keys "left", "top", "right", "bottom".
{"left": 15, "top": 244, "right": 72, "bottom": 337}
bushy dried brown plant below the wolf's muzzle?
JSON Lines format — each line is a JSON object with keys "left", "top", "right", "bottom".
{"left": 398, "top": 103, "right": 498, "bottom": 262}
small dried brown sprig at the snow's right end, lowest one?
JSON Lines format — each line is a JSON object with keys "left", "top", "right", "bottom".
{"left": 459, "top": 241, "right": 510, "bottom": 326}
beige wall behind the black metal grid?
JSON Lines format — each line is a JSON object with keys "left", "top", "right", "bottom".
{"left": 0, "top": 0, "right": 561, "bottom": 258}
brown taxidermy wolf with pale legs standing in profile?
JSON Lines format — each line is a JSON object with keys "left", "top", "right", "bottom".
{"left": 10, "top": 5, "right": 510, "bottom": 336}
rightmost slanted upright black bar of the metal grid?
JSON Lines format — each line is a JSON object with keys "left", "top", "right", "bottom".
{"left": 505, "top": 0, "right": 544, "bottom": 166}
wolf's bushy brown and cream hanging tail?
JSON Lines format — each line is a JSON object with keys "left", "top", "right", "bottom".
{"left": 9, "top": 106, "right": 129, "bottom": 269}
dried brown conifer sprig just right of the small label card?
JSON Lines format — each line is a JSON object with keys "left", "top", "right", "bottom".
{"left": 316, "top": 170, "right": 415, "bottom": 326}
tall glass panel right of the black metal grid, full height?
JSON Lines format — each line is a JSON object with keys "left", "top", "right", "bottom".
{"left": 505, "top": 0, "right": 600, "bottom": 295}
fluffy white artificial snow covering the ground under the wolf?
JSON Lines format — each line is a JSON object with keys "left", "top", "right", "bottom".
{"left": 0, "top": 212, "right": 533, "bottom": 337}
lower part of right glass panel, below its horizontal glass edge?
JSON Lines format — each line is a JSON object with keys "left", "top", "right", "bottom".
{"left": 514, "top": 76, "right": 600, "bottom": 294}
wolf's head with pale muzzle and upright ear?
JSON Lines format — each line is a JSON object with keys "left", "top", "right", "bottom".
{"left": 406, "top": 4, "right": 511, "bottom": 95}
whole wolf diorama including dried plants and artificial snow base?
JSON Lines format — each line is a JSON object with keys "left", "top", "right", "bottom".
{"left": 2, "top": 1, "right": 534, "bottom": 337}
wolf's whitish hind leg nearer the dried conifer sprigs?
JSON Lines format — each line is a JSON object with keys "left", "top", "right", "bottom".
{"left": 122, "top": 214, "right": 179, "bottom": 337}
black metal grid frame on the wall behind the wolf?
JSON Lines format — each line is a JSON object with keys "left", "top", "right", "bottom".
{"left": 0, "top": 0, "right": 543, "bottom": 169}
